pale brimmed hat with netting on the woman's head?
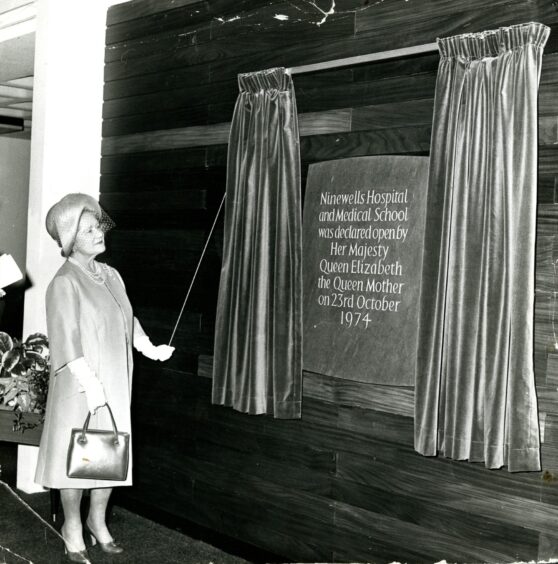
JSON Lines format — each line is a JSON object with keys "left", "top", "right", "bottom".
{"left": 46, "top": 193, "right": 114, "bottom": 257}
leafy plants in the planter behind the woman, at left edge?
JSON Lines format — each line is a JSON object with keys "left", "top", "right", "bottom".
{"left": 0, "top": 332, "right": 50, "bottom": 436}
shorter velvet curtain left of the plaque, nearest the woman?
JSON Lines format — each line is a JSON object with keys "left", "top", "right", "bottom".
{"left": 212, "top": 68, "right": 302, "bottom": 418}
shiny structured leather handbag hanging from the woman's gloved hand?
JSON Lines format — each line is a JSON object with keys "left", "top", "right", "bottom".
{"left": 66, "top": 403, "right": 130, "bottom": 481}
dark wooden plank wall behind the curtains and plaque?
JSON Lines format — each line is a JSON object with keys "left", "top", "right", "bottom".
{"left": 101, "top": 0, "right": 558, "bottom": 562}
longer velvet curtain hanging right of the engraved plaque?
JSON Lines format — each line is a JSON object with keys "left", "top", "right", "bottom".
{"left": 415, "top": 23, "right": 549, "bottom": 471}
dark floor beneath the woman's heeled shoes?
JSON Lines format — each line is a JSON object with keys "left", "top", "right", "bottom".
{"left": 0, "top": 468, "right": 255, "bottom": 564}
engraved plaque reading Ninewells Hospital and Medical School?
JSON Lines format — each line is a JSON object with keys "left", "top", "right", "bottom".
{"left": 303, "top": 156, "right": 428, "bottom": 386}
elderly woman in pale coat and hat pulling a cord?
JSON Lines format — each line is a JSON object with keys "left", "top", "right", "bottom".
{"left": 35, "top": 194, "right": 174, "bottom": 563}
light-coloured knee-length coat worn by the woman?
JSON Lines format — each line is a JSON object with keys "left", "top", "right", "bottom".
{"left": 35, "top": 261, "right": 145, "bottom": 489}
